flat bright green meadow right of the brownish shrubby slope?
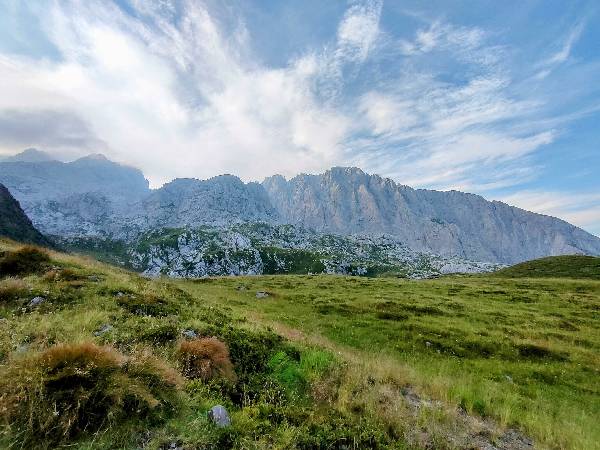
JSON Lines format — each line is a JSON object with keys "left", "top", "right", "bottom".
{"left": 179, "top": 276, "right": 600, "bottom": 449}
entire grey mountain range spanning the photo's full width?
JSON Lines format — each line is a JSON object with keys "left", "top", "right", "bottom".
{"left": 0, "top": 149, "right": 600, "bottom": 274}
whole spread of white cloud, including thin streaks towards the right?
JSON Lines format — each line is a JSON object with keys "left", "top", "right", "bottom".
{"left": 0, "top": 0, "right": 592, "bottom": 223}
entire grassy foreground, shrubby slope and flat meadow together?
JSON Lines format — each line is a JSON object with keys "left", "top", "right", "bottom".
{"left": 0, "top": 242, "right": 600, "bottom": 449}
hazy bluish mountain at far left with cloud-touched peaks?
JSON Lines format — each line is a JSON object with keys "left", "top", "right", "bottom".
{"left": 0, "top": 150, "right": 150, "bottom": 235}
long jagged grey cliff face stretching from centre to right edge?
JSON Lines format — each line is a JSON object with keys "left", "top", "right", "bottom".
{"left": 263, "top": 167, "right": 600, "bottom": 263}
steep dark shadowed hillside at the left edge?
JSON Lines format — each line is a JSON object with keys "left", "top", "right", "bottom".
{"left": 0, "top": 184, "right": 52, "bottom": 247}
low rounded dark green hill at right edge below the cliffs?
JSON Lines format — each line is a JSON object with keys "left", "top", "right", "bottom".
{"left": 496, "top": 255, "right": 600, "bottom": 280}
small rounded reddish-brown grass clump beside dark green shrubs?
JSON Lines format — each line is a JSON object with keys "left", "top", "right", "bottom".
{"left": 177, "top": 337, "right": 236, "bottom": 381}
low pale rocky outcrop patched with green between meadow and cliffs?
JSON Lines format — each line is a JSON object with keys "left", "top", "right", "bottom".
{"left": 61, "top": 223, "right": 500, "bottom": 278}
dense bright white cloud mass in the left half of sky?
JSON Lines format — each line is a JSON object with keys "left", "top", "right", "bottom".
{"left": 0, "top": 2, "right": 360, "bottom": 184}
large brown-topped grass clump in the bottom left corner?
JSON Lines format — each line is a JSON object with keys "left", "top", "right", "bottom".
{"left": 0, "top": 342, "right": 180, "bottom": 448}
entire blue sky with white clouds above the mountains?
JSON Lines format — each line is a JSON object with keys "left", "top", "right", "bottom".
{"left": 0, "top": 0, "right": 600, "bottom": 235}
